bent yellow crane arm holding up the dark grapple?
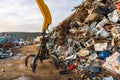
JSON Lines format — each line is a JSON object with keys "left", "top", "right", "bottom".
{"left": 36, "top": 0, "right": 52, "bottom": 33}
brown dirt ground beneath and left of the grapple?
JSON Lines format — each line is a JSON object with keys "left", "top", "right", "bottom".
{"left": 0, "top": 45, "right": 70, "bottom": 80}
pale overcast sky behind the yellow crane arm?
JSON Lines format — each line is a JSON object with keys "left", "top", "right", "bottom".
{"left": 0, "top": 0, "right": 82, "bottom": 32}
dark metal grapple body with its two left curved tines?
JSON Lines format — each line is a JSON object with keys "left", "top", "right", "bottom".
{"left": 25, "top": 34, "right": 50, "bottom": 72}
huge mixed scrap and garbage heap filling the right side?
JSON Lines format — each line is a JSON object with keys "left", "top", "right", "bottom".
{"left": 47, "top": 0, "right": 120, "bottom": 80}
